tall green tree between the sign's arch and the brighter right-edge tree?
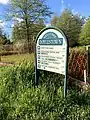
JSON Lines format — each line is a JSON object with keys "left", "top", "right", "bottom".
{"left": 51, "top": 9, "right": 84, "bottom": 46}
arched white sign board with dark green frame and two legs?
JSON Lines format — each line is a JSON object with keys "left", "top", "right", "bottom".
{"left": 35, "top": 27, "right": 69, "bottom": 97}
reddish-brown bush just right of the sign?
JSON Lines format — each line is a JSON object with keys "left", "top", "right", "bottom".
{"left": 68, "top": 48, "right": 87, "bottom": 81}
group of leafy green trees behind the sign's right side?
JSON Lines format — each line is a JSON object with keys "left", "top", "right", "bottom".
{"left": 51, "top": 9, "right": 90, "bottom": 47}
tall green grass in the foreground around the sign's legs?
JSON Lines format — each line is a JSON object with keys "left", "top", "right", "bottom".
{"left": 0, "top": 62, "right": 90, "bottom": 120}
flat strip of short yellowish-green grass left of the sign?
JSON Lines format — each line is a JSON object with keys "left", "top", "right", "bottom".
{"left": 1, "top": 54, "right": 34, "bottom": 64}
